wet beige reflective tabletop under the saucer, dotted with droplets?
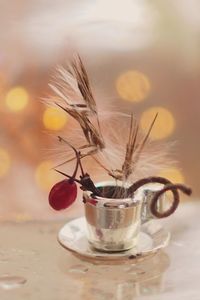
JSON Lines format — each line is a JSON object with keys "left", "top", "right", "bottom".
{"left": 0, "top": 200, "right": 200, "bottom": 300}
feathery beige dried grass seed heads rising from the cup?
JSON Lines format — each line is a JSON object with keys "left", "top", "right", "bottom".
{"left": 49, "top": 55, "right": 173, "bottom": 182}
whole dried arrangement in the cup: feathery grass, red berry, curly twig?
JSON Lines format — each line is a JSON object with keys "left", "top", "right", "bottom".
{"left": 46, "top": 55, "right": 192, "bottom": 218}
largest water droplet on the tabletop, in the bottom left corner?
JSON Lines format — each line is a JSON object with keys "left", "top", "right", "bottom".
{"left": 0, "top": 275, "right": 27, "bottom": 290}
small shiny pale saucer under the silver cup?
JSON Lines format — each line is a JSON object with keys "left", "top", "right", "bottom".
{"left": 58, "top": 217, "right": 170, "bottom": 261}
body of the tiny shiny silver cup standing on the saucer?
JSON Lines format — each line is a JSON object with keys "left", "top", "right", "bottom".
{"left": 83, "top": 183, "right": 142, "bottom": 252}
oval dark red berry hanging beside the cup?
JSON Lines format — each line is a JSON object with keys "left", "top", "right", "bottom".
{"left": 49, "top": 179, "right": 77, "bottom": 210}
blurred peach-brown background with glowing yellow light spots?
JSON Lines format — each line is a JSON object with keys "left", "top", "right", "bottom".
{"left": 0, "top": 0, "right": 200, "bottom": 222}
